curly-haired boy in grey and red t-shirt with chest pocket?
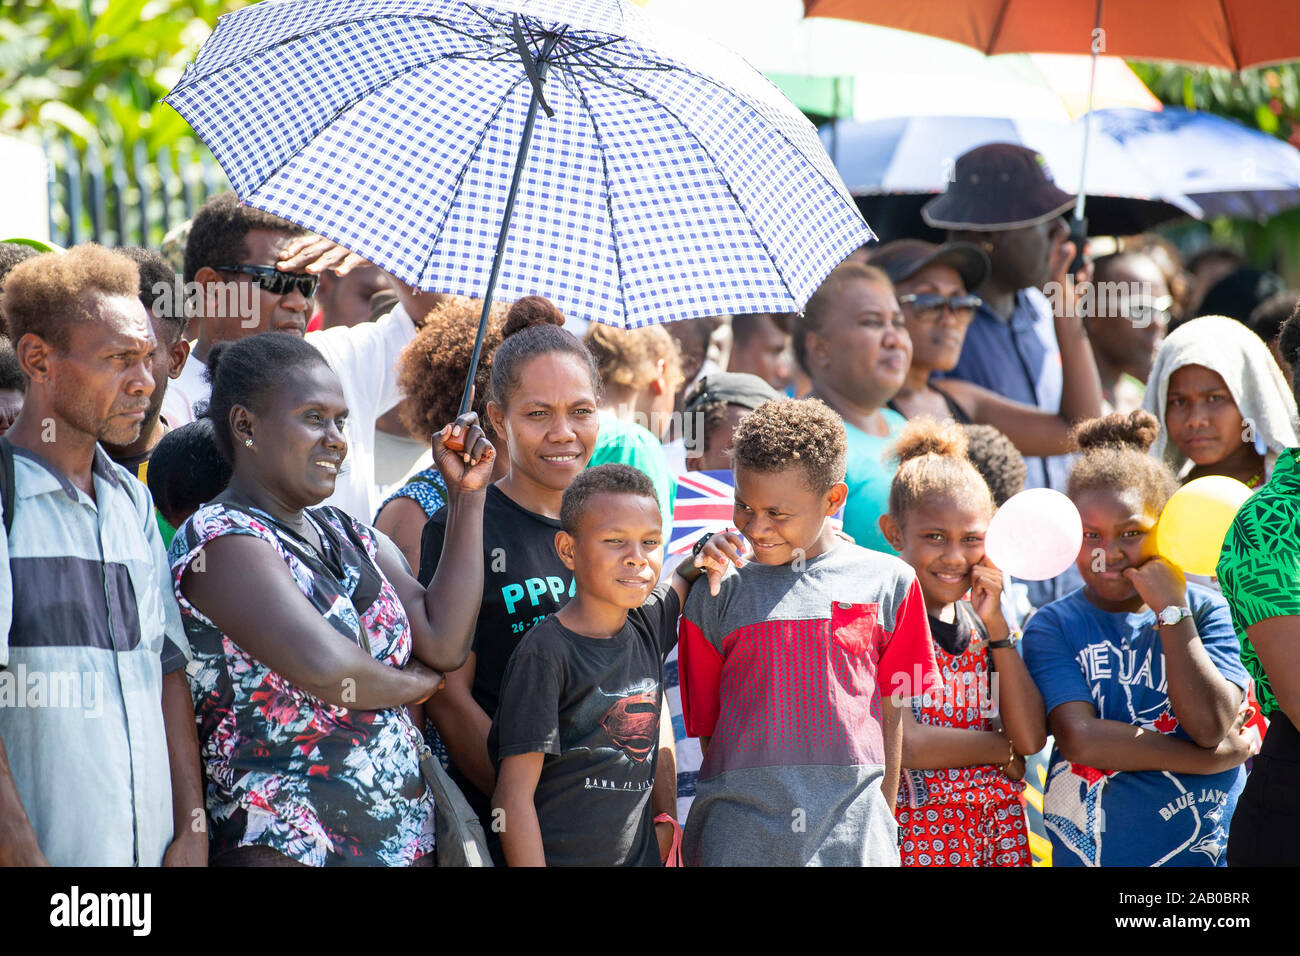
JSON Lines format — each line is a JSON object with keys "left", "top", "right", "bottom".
{"left": 679, "top": 399, "right": 941, "bottom": 866}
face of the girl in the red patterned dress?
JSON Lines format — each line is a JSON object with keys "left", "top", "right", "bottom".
{"left": 885, "top": 494, "right": 989, "bottom": 613}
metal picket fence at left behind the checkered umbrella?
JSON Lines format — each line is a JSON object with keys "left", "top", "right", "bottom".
{"left": 44, "top": 138, "right": 229, "bottom": 248}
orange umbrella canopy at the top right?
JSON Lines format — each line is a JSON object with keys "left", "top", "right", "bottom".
{"left": 803, "top": 0, "right": 1300, "bottom": 70}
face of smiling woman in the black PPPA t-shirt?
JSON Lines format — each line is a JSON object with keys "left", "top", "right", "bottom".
{"left": 488, "top": 352, "right": 599, "bottom": 492}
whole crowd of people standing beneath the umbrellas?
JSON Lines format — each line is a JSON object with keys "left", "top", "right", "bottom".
{"left": 0, "top": 144, "right": 1300, "bottom": 866}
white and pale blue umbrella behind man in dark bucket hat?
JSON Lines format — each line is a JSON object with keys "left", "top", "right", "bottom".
{"left": 822, "top": 111, "right": 1200, "bottom": 238}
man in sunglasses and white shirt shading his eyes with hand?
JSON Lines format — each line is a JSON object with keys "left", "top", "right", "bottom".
{"left": 163, "top": 193, "right": 430, "bottom": 522}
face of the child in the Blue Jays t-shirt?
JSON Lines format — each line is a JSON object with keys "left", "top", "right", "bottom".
{"left": 1074, "top": 488, "right": 1160, "bottom": 610}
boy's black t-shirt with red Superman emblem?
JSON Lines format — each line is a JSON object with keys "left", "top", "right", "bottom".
{"left": 488, "top": 583, "right": 681, "bottom": 866}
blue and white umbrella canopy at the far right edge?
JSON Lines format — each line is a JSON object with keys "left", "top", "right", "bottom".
{"left": 1089, "top": 107, "right": 1300, "bottom": 220}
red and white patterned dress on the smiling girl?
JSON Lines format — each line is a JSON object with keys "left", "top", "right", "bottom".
{"left": 898, "top": 601, "right": 1030, "bottom": 866}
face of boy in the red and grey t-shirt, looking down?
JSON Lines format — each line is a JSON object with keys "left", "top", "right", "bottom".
{"left": 732, "top": 464, "right": 848, "bottom": 564}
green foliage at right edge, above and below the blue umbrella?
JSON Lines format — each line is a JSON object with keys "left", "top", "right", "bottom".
{"left": 1130, "top": 62, "right": 1300, "bottom": 280}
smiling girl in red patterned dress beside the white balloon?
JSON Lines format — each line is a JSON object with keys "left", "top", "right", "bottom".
{"left": 880, "top": 418, "right": 1047, "bottom": 866}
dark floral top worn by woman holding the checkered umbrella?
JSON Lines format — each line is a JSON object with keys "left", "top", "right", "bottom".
{"left": 170, "top": 503, "right": 434, "bottom": 866}
